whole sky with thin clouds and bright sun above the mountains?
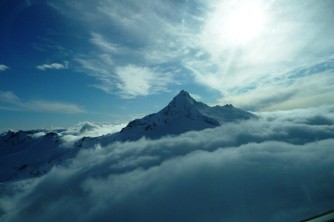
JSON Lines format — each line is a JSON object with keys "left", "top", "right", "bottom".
{"left": 0, "top": 0, "right": 334, "bottom": 130}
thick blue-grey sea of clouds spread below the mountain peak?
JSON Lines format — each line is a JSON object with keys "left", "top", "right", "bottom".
{"left": 0, "top": 106, "right": 334, "bottom": 222}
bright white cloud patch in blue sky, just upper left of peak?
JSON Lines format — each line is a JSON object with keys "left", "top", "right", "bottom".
{"left": 76, "top": 54, "right": 175, "bottom": 98}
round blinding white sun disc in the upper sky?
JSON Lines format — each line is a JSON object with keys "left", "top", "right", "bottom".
{"left": 225, "top": 4, "right": 265, "bottom": 44}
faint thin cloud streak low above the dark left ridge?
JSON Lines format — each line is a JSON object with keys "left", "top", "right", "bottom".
{"left": 0, "top": 91, "right": 85, "bottom": 114}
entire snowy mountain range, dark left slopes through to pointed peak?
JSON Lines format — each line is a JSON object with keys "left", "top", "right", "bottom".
{"left": 0, "top": 90, "right": 256, "bottom": 182}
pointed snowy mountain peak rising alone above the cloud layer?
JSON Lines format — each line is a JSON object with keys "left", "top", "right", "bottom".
{"left": 115, "top": 90, "right": 256, "bottom": 140}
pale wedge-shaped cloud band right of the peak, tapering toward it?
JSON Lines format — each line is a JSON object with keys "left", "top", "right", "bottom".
{"left": 220, "top": 66, "right": 334, "bottom": 110}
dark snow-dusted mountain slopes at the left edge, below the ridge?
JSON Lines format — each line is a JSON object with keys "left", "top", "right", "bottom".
{"left": 0, "top": 130, "right": 75, "bottom": 182}
